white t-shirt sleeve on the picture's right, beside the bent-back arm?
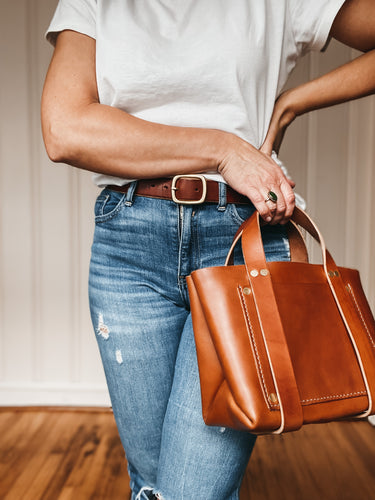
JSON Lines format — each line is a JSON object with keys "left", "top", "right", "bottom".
{"left": 289, "top": 0, "right": 345, "bottom": 55}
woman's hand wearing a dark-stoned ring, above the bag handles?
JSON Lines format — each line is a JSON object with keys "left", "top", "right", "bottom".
{"left": 218, "top": 136, "right": 295, "bottom": 224}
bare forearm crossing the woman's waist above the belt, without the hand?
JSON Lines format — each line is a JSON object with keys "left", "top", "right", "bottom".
{"left": 44, "top": 99, "right": 234, "bottom": 178}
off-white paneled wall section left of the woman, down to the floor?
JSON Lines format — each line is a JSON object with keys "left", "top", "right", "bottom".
{"left": 0, "top": 0, "right": 109, "bottom": 405}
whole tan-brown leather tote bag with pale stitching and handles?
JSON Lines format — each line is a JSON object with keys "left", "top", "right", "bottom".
{"left": 188, "top": 208, "right": 375, "bottom": 434}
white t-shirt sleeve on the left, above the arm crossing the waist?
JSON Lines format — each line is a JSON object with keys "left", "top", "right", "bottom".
{"left": 46, "top": 0, "right": 96, "bottom": 45}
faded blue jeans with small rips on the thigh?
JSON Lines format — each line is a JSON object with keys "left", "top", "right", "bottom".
{"left": 89, "top": 183, "right": 289, "bottom": 500}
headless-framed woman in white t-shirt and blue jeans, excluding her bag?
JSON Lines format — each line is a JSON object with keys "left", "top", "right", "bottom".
{"left": 42, "top": 0, "right": 375, "bottom": 500}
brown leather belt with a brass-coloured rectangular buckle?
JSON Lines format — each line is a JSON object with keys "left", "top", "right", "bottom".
{"left": 107, "top": 175, "right": 251, "bottom": 205}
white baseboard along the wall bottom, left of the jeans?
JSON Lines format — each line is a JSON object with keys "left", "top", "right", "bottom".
{"left": 0, "top": 382, "right": 111, "bottom": 407}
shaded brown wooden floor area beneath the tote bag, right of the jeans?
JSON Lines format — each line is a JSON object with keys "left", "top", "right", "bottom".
{"left": 240, "top": 422, "right": 375, "bottom": 500}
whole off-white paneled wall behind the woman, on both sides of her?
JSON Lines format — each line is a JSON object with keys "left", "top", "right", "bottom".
{"left": 0, "top": 0, "right": 375, "bottom": 405}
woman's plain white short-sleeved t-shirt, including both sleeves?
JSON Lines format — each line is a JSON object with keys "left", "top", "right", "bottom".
{"left": 47, "top": 0, "right": 344, "bottom": 186}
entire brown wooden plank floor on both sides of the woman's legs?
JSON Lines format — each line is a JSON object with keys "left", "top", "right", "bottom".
{"left": 0, "top": 408, "right": 375, "bottom": 500}
